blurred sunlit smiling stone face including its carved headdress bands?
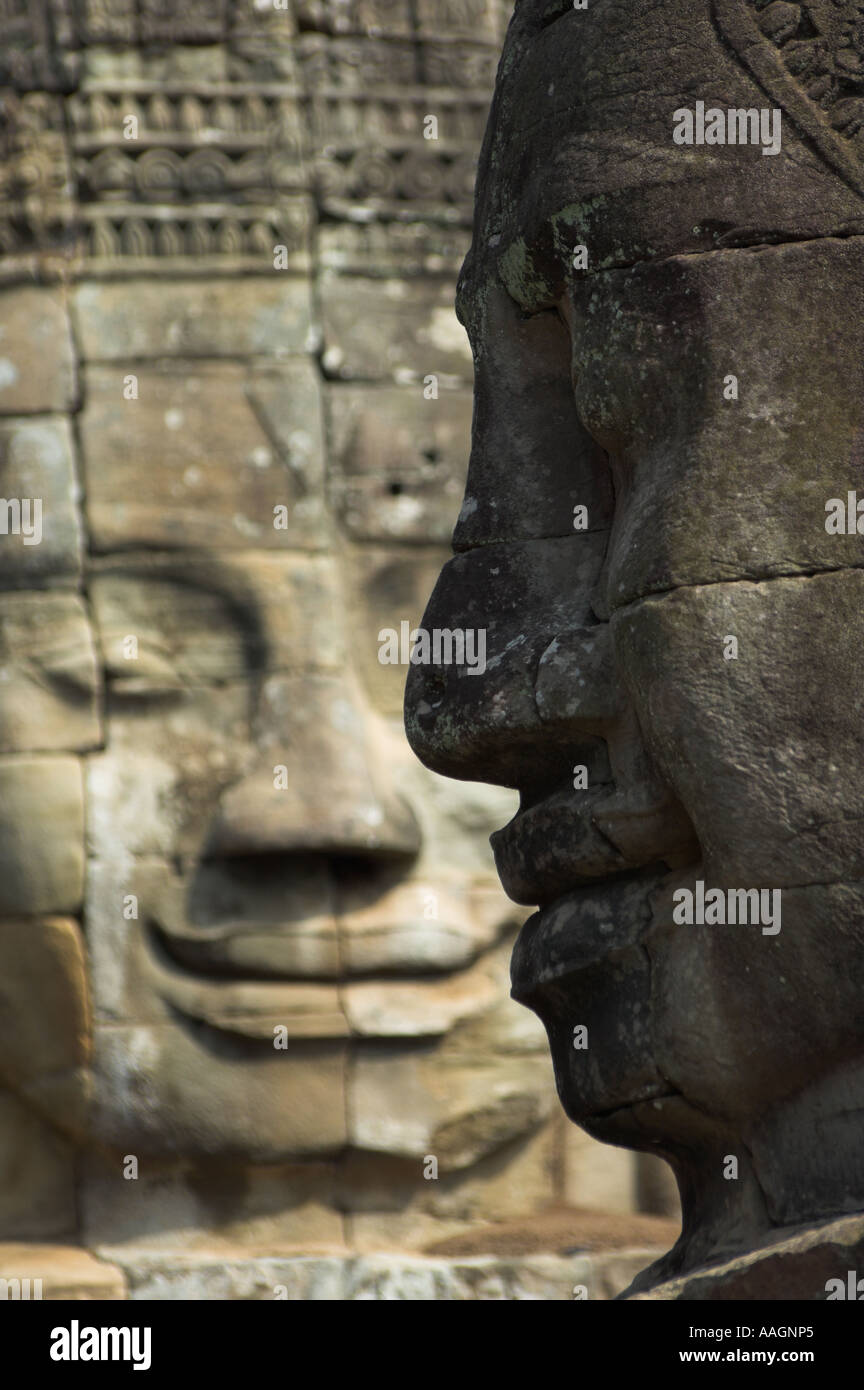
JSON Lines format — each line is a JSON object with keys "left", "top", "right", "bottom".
{"left": 0, "top": 0, "right": 605, "bottom": 1248}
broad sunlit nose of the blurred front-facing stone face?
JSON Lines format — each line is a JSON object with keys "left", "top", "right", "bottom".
{"left": 206, "top": 676, "right": 421, "bottom": 859}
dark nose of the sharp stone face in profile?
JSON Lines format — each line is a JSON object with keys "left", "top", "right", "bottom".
{"left": 406, "top": 534, "right": 622, "bottom": 788}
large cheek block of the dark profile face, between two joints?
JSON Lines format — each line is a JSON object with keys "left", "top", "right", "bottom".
{"left": 611, "top": 570, "right": 864, "bottom": 888}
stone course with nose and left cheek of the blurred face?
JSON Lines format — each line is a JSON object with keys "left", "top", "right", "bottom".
{"left": 89, "top": 674, "right": 418, "bottom": 860}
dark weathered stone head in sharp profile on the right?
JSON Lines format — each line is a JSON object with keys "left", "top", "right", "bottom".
{"left": 406, "top": 0, "right": 864, "bottom": 1295}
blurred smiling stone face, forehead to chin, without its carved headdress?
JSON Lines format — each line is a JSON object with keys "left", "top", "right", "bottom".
{"left": 0, "top": 279, "right": 569, "bottom": 1244}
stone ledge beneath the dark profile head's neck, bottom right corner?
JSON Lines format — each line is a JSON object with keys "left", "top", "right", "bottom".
{"left": 618, "top": 1212, "right": 864, "bottom": 1302}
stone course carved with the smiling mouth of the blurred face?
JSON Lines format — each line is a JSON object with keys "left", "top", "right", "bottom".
{"left": 88, "top": 859, "right": 522, "bottom": 1052}
